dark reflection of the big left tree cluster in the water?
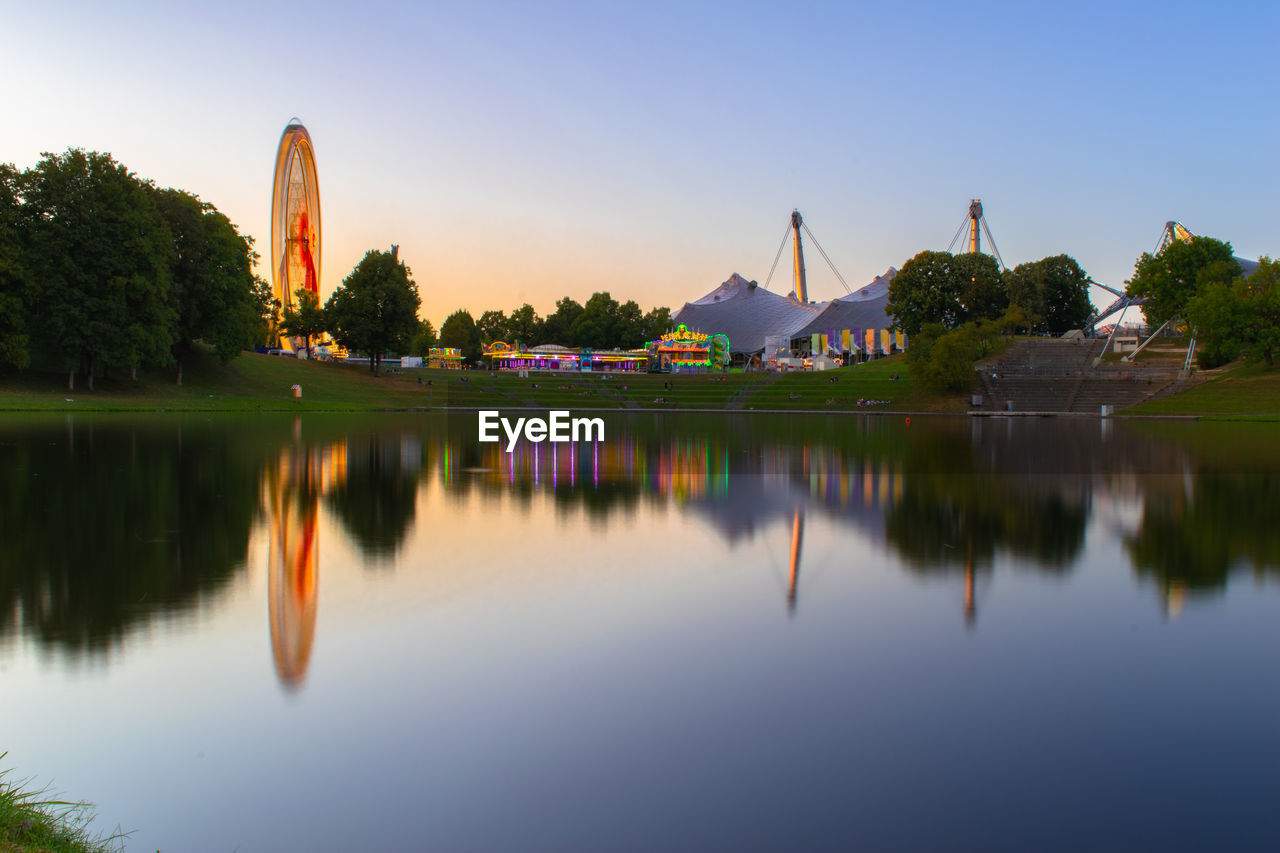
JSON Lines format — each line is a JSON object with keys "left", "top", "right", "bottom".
{"left": 0, "top": 416, "right": 270, "bottom": 656}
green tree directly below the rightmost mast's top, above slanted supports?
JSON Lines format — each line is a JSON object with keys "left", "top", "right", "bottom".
{"left": 1125, "top": 237, "right": 1240, "bottom": 325}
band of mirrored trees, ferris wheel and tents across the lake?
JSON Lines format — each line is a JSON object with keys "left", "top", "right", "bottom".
{"left": 0, "top": 415, "right": 1280, "bottom": 666}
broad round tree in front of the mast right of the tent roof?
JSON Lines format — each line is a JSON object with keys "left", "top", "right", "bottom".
{"left": 886, "top": 251, "right": 1009, "bottom": 336}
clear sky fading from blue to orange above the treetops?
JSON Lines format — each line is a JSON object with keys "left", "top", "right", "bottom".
{"left": 0, "top": 0, "right": 1280, "bottom": 328}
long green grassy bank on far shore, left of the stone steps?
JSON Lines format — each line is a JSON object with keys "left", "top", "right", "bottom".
{"left": 0, "top": 352, "right": 966, "bottom": 412}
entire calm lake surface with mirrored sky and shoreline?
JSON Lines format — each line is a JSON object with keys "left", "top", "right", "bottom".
{"left": 0, "top": 415, "right": 1280, "bottom": 852}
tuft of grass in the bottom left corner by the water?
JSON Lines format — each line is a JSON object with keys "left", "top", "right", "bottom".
{"left": 0, "top": 753, "right": 123, "bottom": 853}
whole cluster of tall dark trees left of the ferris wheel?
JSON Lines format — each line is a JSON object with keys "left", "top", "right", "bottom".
{"left": 0, "top": 149, "right": 271, "bottom": 389}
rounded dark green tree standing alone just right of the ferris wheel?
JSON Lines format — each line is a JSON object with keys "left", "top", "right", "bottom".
{"left": 324, "top": 250, "right": 422, "bottom": 374}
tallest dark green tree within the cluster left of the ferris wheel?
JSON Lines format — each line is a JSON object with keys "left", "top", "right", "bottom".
{"left": 23, "top": 149, "right": 178, "bottom": 391}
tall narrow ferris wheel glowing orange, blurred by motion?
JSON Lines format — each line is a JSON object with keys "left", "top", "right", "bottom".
{"left": 271, "top": 118, "right": 320, "bottom": 313}
